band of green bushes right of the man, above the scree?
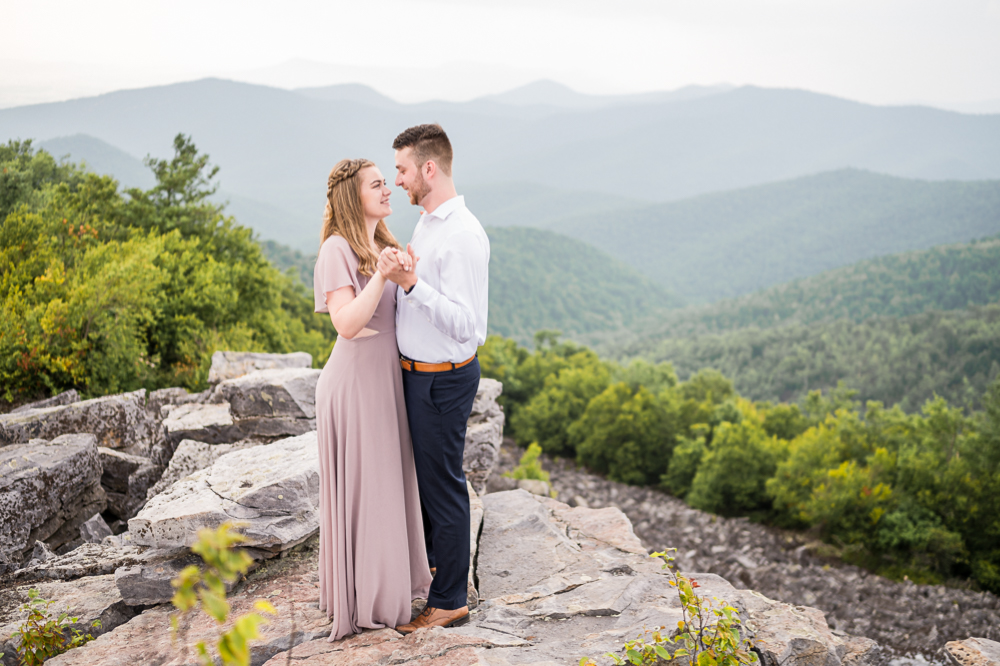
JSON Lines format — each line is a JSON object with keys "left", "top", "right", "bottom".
{"left": 480, "top": 333, "right": 1000, "bottom": 592}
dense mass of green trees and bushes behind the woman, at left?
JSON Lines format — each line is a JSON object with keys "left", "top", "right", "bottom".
{"left": 0, "top": 135, "right": 334, "bottom": 402}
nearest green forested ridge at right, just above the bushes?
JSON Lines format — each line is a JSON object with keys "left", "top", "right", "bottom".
{"left": 624, "top": 305, "right": 1000, "bottom": 411}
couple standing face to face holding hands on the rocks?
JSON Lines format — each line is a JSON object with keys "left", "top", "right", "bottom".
{"left": 313, "top": 125, "right": 490, "bottom": 641}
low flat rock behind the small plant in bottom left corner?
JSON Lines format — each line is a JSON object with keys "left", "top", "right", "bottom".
{"left": 0, "top": 576, "right": 135, "bottom": 666}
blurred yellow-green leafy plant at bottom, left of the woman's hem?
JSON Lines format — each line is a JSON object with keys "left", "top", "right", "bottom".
{"left": 170, "top": 523, "right": 277, "bottom": 666}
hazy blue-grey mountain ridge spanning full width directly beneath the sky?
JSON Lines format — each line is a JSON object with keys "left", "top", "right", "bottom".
{"left": 0, "top": 79, "right": 1000, "bottom": 249}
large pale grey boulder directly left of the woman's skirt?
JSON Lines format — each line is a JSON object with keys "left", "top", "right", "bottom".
{"left": 128, "top": 432, "right": 319, "bottom": 551}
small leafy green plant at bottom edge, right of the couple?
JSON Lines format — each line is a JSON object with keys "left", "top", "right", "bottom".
{"left": 580, "top": 548, "right": 758, "bottom": 666}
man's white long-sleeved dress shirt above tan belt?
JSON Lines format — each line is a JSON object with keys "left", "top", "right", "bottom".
{"left": 396, "top": 196, "right": 490, "bottom": 363}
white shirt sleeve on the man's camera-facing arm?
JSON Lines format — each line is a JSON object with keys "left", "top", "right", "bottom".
{"left": 403, "top": 231, "right": 488, "bottom": 343}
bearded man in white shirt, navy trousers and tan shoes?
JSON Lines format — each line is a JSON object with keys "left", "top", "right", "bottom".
{"left": 379, "top": 125, "right": 490, "bottom": 634}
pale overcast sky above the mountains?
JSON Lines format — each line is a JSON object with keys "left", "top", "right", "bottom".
{"left": 0, "top": 0, "right": 1000, "bottom": 106}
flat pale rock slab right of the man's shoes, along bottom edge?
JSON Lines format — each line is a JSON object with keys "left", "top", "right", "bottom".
{"left": 250, "top": 490, "right": 878, "bottom": 666}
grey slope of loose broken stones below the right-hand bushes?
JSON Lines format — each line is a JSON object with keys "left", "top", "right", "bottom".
{"left": 516, "top": 444, "right": 1000, "bottom": 662}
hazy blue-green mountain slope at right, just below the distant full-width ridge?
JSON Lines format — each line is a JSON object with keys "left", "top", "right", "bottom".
{"left": 548, "top": 170, "right": 1000, "bottom": 303}
